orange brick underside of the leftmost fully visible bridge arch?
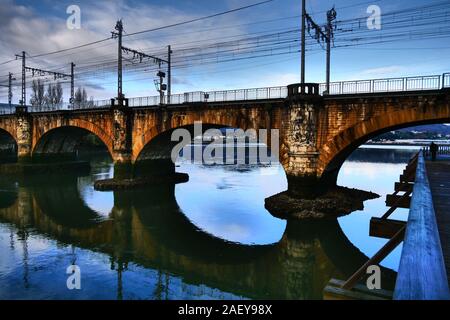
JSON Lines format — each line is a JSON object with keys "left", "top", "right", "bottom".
{"left": 32, "top": 119, "right": 113, "bottom": 157}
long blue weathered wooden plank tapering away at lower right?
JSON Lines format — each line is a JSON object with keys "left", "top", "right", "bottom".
{"left": 394, "top": 153, "right": 450, "bottom": 300}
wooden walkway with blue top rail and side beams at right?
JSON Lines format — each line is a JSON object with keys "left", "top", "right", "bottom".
{"left": 324, "top": 150, "right": 450, "bottom": 300}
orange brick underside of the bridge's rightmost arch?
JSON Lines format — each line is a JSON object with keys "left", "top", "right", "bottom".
{"left": 317, "top": 105, "right": 450, "bottom": 179}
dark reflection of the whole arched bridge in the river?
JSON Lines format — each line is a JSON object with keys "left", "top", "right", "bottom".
{"left": 0, "top": 177, "right": 395, "bottom": 299}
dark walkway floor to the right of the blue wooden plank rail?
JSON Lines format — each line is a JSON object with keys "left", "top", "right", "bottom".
{"left": 426, "top": 156, "right": 450, "bottom": 286}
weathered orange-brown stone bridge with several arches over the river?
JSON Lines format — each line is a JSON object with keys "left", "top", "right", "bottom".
{"left": 0, "top": 84, "right": 450, "bottom": 194}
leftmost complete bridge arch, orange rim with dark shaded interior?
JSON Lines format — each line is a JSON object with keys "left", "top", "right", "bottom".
{"left": 31, "top": 119, "right": 114, "bottom": 158}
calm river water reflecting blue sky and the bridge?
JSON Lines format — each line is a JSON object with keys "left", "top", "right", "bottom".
{"left": 0, "top": 147, "right": 416, "bottom": 299}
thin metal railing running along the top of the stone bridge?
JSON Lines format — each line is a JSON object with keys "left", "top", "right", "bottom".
{"left": 0, "top": 73, "right": 450, "bottom": 115}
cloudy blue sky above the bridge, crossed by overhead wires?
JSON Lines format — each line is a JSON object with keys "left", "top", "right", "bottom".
{"left": 0, "top": 0, "right": 450, "bottom": 101}
